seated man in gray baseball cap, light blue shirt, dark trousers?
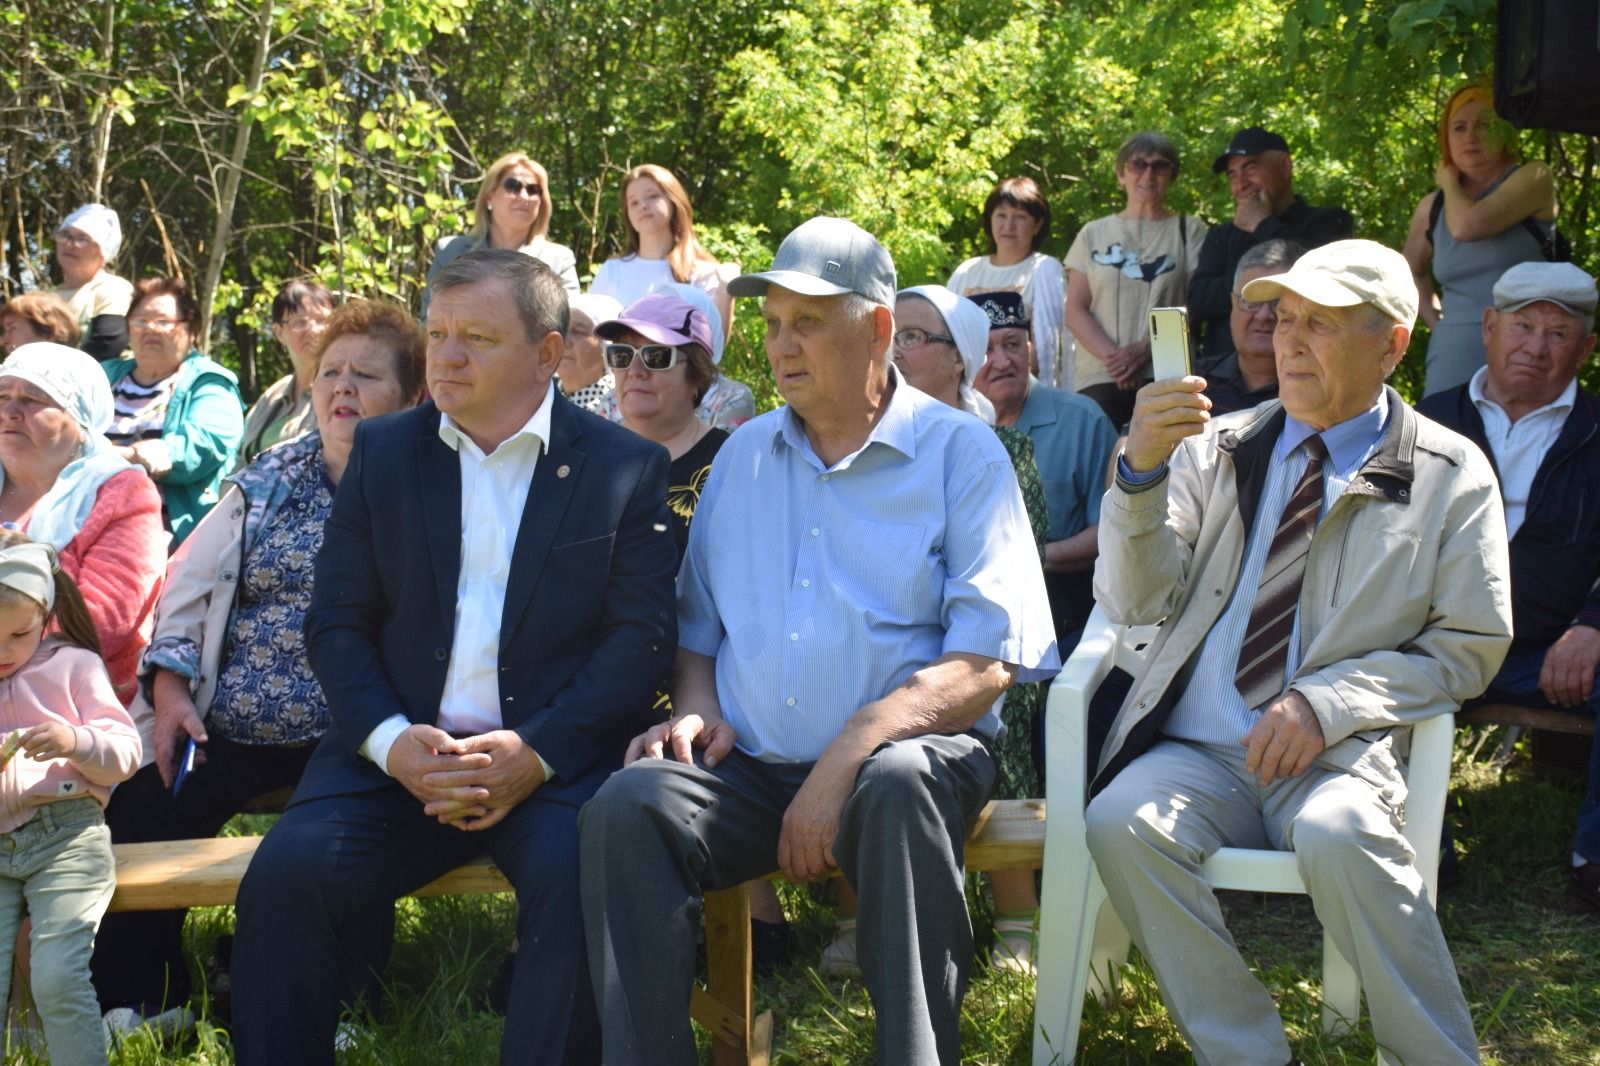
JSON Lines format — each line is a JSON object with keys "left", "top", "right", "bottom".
{"left": 581, "top": 218, "right": 1059, "bottom": 1066}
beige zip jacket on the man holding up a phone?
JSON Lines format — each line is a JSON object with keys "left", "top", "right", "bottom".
{"left": 1091, "top": 389, "right": 1510, "bottom": 807}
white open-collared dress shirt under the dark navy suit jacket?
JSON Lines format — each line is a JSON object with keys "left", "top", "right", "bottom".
{"left": 362, "top": 383, "right": 555, "bottom": 776}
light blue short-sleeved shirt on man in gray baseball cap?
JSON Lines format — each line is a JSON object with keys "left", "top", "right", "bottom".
{"left": 678, "top": 367, "right": 1061, "bottom": 762}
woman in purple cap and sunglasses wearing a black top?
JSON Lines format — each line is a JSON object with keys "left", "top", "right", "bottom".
{"left": 595, "top": 286, "right": 728, "bottom": 562}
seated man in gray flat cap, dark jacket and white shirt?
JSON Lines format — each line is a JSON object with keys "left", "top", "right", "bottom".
{"left": 1421, "top": 262, "right": 1600, "bottom": 909}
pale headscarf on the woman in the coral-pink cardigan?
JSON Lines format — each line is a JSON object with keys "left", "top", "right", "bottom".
{"left": 0, "top": 341, "right": 136, "bottom": 551}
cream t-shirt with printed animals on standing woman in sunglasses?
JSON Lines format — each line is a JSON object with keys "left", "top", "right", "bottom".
{"left": 1067, "top": 214, "right": 1206, "bottom": 389}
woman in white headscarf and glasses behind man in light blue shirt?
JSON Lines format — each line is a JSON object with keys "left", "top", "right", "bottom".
{"left": 821, "top": 285, "right": 1050, "bottom": 973}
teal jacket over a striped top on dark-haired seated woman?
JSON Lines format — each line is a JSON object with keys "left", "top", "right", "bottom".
{"left": 102, "top": 351, "right": 245, "bottom": 549}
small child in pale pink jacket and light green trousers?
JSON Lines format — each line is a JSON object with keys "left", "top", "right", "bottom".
{"left": 0, "top": 531, "right": 141, "bottom": 1064}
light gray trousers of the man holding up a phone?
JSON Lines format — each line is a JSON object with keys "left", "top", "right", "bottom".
{"left": 1085, "top": 739, "right": 1478, "bottom": 1066}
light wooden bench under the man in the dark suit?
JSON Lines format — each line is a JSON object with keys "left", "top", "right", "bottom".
{"left": 110, "top": 800, "right": 1045, "bottom": 1066}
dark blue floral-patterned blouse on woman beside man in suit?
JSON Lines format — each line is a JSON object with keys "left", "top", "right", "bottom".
{"left": 206, "top": 451, "right": 333, "bottom": 746}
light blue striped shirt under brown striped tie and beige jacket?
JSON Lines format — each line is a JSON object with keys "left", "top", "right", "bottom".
{"left": 1162, "top": 392, "right": 1389, "bottom": 744}
